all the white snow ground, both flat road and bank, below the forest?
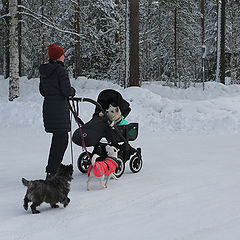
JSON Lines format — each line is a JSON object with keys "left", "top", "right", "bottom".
{"left": 0, "top": 76, "right": 240, "bottom": 240}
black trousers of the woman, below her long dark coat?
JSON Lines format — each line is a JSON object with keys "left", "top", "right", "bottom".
{"left": 46, "top": 133, "right": 68, "bottom": 174}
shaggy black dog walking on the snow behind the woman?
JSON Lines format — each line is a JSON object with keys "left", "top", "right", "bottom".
{"left": 22, "top": 164, "right": 73, "bottom": 214}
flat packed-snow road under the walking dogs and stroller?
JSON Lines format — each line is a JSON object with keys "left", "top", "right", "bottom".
{"left": 0, "top": 128, "right": 240, "bottom": 240}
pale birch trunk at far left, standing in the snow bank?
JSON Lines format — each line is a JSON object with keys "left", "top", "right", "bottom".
{"left": 9, "top": 0, "right": 19, "bottom": 101}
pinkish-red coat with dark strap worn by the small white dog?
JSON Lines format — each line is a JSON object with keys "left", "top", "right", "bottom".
{"left": 88, "top": 158, "right": 118, "bottom": 177}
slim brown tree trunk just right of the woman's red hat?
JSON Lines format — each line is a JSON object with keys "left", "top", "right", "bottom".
{"left": 75, "top": 0, "right": 81, "bottom": 78}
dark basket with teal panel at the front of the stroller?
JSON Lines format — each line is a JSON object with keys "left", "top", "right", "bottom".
{"left": 116, "top": 123, "right": 138, "bottom": 142}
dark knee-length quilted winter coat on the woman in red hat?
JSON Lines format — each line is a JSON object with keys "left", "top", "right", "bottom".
{"left": 39, "top": 60, "right": 75, "bottom": 133}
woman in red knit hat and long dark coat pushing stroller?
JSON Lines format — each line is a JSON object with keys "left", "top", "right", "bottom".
{"left": 39, "top": 44, "right": 75, "bottom": 177}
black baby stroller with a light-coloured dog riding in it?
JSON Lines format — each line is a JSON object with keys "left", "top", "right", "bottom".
{"left": 69, "top": 89, "right": 143, "bottom": 178}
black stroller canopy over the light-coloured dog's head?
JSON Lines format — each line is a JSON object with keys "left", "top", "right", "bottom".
{"left": 95, "top": 89, "right": 131, "bottom": 118}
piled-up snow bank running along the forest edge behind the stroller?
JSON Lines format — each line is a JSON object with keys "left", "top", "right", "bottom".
{"left": 0, "top": 77, "right": 240, "bottom": 133}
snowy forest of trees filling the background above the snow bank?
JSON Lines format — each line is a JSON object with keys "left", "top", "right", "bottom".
{"left": 0, "top": 0, "right": 240, "bottom": 100}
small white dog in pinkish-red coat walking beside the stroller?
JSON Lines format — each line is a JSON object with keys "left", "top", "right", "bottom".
{"left": 87, "top": 145, "right": 119, "bottom": 191}
